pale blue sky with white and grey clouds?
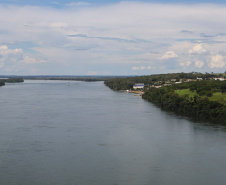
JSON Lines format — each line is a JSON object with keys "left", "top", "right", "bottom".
{"left": 0, "top": 0, "right": 226, "bottom": 75}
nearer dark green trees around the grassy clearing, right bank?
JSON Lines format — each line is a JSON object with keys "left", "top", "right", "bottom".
{"left": 142, "top": 80, "right": 226, "bottom": 123}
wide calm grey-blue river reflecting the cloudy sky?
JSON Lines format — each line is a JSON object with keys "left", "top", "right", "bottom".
{"left": 0, "top": 80, "right": 226, "bottom": 185}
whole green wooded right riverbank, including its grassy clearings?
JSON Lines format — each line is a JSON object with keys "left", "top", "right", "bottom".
{"left": 105, "top": 73, "right": 226, "bottom": 123}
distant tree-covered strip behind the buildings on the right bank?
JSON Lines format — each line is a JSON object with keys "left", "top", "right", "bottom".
{"left": 105, "top": 72, "right": 223, "bottom": 91}
